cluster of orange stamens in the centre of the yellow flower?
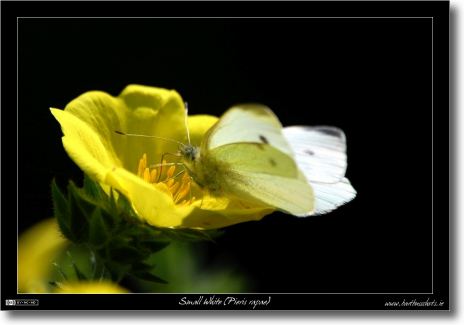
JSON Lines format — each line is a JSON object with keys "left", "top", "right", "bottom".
{"left": 137, "top": 154, "right": 195, "bottom": 207}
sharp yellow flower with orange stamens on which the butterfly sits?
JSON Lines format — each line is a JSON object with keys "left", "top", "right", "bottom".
{"left": 51, "top": 85, "right": 275, "bottom": 229}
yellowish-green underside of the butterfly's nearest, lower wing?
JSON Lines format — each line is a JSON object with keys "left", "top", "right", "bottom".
{"left": 202, "top": 142, "right": 314, "bottom": 216}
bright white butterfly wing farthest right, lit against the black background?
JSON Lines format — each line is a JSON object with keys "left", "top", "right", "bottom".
{"left": 283, "top": 126, "right": 356, "bottom": 214}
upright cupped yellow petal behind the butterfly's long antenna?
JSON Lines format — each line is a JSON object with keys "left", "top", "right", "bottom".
{"left": 57, "top": 85, "right": 187, "bottom": 173}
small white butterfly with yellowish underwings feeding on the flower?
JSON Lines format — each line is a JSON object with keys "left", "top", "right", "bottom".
{"left": 179, "top": 104, "right": 356, "bottom": 216}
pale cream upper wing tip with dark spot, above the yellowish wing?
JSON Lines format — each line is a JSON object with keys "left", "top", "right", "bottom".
{"left": 201, "top": 104, "right": 293, "bottom": 156}
